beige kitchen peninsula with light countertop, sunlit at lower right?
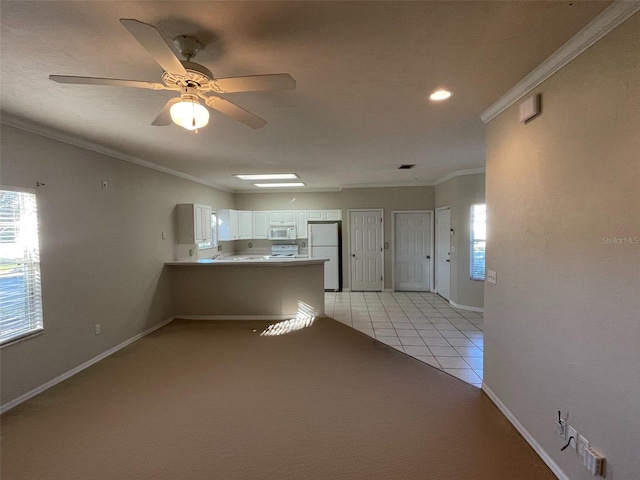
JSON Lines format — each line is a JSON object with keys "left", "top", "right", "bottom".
{"left": 165, "top": 256, "right": 326, "bottom": 320}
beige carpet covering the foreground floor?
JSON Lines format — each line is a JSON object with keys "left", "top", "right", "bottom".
{"left": 0, "top": 318, "right": 555, "bottom": 480}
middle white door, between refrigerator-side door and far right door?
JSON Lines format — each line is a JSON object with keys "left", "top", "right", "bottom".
{"left": 394, "top": 212, "right": 431, "bottom": 292}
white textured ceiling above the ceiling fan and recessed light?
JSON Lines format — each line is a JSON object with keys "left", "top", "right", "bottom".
{"left": 0, "top": 0, "right": 610, "bottom": 191}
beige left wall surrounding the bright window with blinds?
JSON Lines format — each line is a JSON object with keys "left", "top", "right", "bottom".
{"left": 0, "top": 125, "right": 233, "bottom": 405}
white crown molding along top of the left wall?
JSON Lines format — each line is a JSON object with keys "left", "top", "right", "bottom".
{"left": 0, "top": 113, "right": 234, "bottom": 193}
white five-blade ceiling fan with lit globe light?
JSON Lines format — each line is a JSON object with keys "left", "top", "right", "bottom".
{"left": 49, "top": 18, "right": 296, "bottom": 133}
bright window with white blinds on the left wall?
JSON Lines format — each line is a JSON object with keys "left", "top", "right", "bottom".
{"left": 0, "top": 189, "right": 42, "bottom": 345}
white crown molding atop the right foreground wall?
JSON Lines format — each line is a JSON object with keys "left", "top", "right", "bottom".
{"left": 480, "top": 0, "right": 640, "bottom": 123}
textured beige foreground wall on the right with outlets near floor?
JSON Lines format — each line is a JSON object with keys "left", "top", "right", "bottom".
{"left": 484, "top": 14, "right": 640, "bottom": 480}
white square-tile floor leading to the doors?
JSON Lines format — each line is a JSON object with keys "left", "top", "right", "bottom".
{"left": 324, "top": 292, "right": 484, "bottom": 387}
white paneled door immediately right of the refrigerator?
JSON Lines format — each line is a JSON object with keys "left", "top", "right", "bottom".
{"left": 349, "top": 210, "right": 384, "bottom": 292}
